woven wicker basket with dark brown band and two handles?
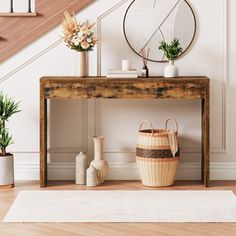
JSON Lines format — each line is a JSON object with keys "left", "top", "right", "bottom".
{"left": 136, "top": 119, "right": 180, "bottom": 187}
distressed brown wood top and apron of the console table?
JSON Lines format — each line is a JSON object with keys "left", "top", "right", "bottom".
{"left": 41, "top": 77, "right": 209, "bottom": 99}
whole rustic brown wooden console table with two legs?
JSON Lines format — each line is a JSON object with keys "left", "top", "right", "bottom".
{"left": 40, "top": 76, "right": 210, "bottom": 187}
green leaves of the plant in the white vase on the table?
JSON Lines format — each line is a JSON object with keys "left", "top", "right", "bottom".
{"left": 158, "top": 39, "right": 183, "bottom": 61}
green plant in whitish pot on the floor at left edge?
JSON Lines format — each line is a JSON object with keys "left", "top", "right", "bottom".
{"left": 0, "top": 92, "right": 20, "bottom": 188}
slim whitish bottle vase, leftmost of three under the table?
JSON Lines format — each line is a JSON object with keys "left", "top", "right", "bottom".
{"left": 75, "top": 152, "right": 88, "bottom": 185}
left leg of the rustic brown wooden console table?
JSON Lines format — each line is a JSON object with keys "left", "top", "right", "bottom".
{"left": 40, "top": 85, "right": 47, "bottom": 188}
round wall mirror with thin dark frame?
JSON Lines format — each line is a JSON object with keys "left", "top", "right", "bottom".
{"left": 123, "top": 0, "right": 196, "bottom": 62}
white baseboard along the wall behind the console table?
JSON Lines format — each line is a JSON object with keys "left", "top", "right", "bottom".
{"left": 15, "top": 162, "right": 236, "bottom": 180}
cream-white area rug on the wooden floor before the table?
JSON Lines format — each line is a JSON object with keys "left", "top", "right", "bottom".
{"left": 4, "top": 190, "right": 236, "bottom": 222}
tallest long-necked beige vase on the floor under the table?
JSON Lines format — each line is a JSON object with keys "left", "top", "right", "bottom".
{"left": 91, "top": 136, "right": 108, "bottom": 184}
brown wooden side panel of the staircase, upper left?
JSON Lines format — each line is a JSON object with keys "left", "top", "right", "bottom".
{"left": 0, "top": 0, "right": 94, "bottom": 63}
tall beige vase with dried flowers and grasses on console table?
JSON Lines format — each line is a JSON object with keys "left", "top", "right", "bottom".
{"left": 62, "top": 12, "right": 98, "bottom": 77}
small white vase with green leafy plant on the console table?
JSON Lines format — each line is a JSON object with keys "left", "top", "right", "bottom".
{"left": 159, "top": 39, "right": 183, "bottom": 77}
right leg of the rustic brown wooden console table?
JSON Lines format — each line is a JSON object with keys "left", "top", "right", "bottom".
{"left": 201, "top": 86, "right": 210, "bottom": 187}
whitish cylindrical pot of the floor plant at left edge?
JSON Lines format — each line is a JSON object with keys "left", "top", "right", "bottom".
{"left": 0, "top": 155, "right": 14, "bottom": 187}
